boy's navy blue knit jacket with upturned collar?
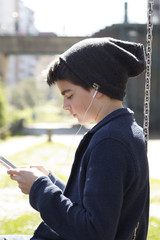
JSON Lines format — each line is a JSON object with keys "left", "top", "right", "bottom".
{"left": 30, "top": 108, "right": 149, "bottom": 240}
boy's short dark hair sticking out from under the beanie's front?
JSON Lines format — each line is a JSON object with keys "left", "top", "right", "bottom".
{"left": 47, "top": 58, "right": 91, "bottom": 91}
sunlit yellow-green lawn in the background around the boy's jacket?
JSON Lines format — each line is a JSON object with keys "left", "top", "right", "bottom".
{"left": 0, "top": 137, "right": 160, "bottom": 240}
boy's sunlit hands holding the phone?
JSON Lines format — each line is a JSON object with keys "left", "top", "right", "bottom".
{"left": 7, "top": 167, "right": 45, "bottom": 194}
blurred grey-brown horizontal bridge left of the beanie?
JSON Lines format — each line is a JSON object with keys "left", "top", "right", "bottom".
{"left": 0, "top": 35, "right": 86, "bottom": 81}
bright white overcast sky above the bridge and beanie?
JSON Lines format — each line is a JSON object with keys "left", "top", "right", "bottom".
{"left": 23, "top": 0, "right": 147, "bottom": 36}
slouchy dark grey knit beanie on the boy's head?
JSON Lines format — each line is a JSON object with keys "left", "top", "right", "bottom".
{"left": 60, "top": 37, "right": 145, "bottom": 100}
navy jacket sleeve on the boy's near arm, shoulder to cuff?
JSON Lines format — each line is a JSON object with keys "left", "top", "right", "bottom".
{"left": 30, "top": 139, "right": 135, "bottom": 240}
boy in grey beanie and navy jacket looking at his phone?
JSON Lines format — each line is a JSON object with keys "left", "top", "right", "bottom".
{"left": 8, "top": 38, "right": 149, "bottom": 240}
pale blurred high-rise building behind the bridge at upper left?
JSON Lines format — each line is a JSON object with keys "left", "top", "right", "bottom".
{"left": 0, "top": 0, "right": 38, "bottom": 86}
